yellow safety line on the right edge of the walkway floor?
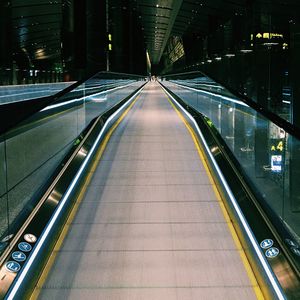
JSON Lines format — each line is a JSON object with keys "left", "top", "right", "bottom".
{"left": 162, "top": 89, "right": 264, "bottom": 300}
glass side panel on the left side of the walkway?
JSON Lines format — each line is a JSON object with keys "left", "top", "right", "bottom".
{"left": 0, "top": 73, "right": 145, "bottom": 251}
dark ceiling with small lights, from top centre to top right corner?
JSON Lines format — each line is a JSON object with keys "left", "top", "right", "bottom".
{"left": 138, "top": 0, "right": 300, "bottom": 64}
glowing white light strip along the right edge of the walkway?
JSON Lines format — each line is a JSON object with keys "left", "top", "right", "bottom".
{"left": 162, "top": 86, "right": 286, "bottom": 300}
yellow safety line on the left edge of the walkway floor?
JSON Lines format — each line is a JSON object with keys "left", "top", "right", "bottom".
{"left": 30, "top": 95, "right": 139, "bottom": 300}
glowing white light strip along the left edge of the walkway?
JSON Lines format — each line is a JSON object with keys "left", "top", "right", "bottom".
{"left": 5, "top": 88, "right": 143, "bottom": 300}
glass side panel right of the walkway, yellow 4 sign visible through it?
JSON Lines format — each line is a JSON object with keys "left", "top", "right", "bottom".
{"left": 162, "top": 74, "right": 300, "bottom": 266}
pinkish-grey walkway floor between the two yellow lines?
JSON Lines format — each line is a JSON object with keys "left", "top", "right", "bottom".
{"left": 38, "top": 83, "right": 256, "bottom": 300}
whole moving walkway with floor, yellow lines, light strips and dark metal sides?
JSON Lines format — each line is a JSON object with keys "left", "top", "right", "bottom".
{"left": 1, "top": 71, "right": 299, "bottom": 299}
